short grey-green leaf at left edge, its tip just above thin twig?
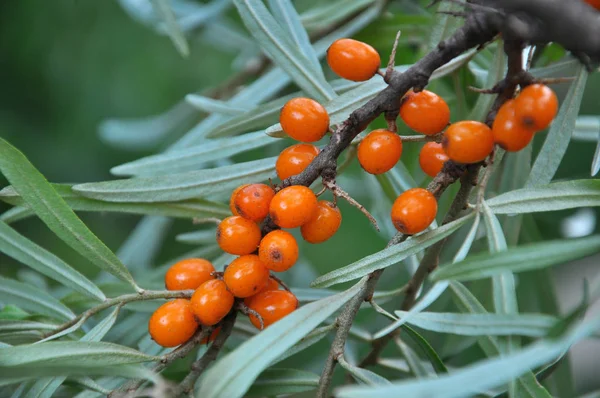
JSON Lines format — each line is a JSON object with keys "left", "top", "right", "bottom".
{"left": 0, "top": 277, "right": 75, "bottom": 321}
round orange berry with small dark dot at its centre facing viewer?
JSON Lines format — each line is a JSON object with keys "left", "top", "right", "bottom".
{"left": 258, "top": 230, "right": 298, "bottom": 272}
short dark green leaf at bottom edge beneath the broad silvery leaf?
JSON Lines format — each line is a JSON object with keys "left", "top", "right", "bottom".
{"left": 244, "top": 369, "right": 319, "bottom": 397}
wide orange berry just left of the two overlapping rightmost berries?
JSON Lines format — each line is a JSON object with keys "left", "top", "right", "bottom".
{"left": 442, "top": 120, "right": 494, "bottom": 163}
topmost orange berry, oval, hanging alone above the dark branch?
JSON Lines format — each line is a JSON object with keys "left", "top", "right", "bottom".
{"left": 327, "top": 39, "right": 381, "bottom": 82}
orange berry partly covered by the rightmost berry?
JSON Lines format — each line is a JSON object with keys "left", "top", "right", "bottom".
{"left": 492, "top": 100, "right": 534, "bottom": 152}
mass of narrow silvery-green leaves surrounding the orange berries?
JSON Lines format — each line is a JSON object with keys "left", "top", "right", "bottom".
{"left": 0, "top": 0, "right": 600, "bottom": 397}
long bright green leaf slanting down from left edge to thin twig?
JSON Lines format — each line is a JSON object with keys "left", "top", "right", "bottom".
{"left": 0, "top": 139, "right": 140, "bottom": 290}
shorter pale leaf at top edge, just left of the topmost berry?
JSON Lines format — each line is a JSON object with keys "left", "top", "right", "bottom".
{"left": 269, "top": 0, "right": 325, "bottom": 73}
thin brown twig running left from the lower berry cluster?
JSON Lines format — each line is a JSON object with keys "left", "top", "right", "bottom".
{"left": 43, "top": 290, "right": 194, "bottom": 338}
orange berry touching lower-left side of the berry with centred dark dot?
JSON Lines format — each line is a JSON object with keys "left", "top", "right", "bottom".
{"left": 223, "top": 254, "right": 269, "bottom": 298}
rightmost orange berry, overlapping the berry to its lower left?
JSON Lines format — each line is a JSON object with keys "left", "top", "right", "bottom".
{"left": 515, "top": 84, "right": 558, "bottom": 131}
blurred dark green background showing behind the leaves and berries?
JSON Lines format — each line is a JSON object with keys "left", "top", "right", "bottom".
{"left": 0, "top": 0, "right": 600, "bottom": 394}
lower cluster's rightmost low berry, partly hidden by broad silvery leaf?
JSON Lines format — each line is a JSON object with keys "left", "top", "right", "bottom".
{"left": 248, "top": 290, "right": 298, "bottom": 329}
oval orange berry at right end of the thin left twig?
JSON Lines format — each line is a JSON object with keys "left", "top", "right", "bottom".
{"left": 165, "top": 258, "right": 215, "bottom": 290}
